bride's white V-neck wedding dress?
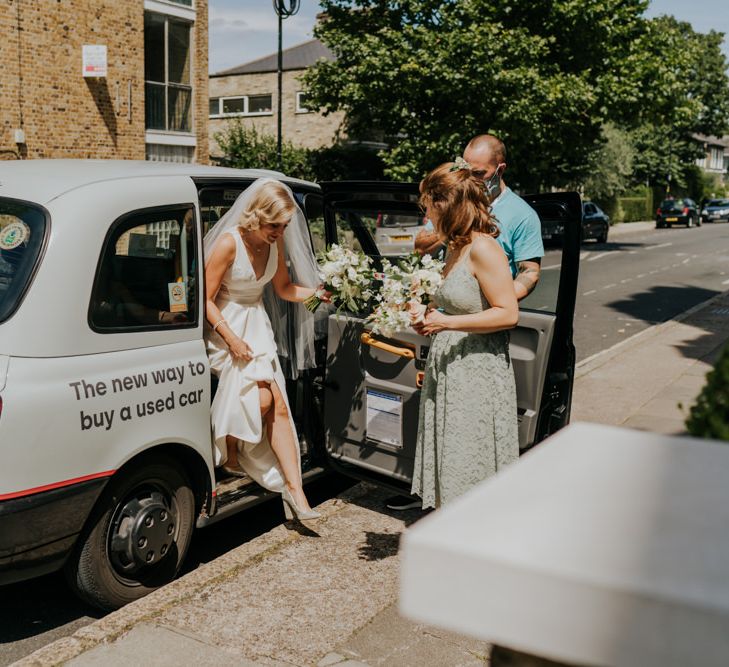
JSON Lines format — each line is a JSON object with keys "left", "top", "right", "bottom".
{"left": 206, "top": 231, "right": 301, "bottom": 493}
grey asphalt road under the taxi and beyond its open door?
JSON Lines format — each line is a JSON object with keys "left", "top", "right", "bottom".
{"left": 0, "top": 224, "right": 729, "bottom": 667}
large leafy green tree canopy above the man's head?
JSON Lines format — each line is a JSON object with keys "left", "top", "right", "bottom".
{"left": 305, "top": 0, "right": 729, "bottom": 190}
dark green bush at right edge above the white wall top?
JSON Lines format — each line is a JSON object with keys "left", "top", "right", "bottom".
{"left": 686, "top": 345, "right": 729, "bottom": 440}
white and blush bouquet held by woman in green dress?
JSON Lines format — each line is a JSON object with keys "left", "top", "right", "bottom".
{"left": 367, "top": 253, "right": 444, "bottom": 336}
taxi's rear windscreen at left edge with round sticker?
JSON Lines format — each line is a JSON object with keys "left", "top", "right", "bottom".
{"left": 0, "top": 198, "right": 47, "bottom": 322}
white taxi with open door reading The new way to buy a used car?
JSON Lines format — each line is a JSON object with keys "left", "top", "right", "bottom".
{"left": 0, "top": 160, "right": 582, "bottom": 609}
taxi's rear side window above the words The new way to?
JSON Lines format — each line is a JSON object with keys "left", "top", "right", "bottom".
{"left": 89, "top": 205, "right": 198, "bottom": 333}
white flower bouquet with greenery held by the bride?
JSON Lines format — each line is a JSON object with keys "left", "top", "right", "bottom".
{"left": 304, "top": 243, "right": 374, "bottom": 312}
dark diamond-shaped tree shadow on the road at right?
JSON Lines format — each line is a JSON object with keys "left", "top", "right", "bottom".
{"left": 605, "top": 285, "right": 719, "bottom": 332}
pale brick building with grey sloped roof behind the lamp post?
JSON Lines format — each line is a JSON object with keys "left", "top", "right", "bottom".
{"left": 209, "top": 39, "right": 344, "bottom": 157}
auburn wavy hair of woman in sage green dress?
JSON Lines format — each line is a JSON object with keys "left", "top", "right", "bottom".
{"left": 420, "top": 162, "right": 499, "bottom": 248}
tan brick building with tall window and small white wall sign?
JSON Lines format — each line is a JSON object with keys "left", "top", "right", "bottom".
{"left": 0, "top": 0, "right": 208, "bottom": 163}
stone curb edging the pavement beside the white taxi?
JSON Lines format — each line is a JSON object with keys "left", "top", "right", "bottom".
{"left": 9, "top": 484, "right": 367, "bottom": 667}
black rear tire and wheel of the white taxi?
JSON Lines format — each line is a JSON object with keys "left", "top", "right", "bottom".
{"left": 65, "top": 456, "right": 195, "bottom": 611}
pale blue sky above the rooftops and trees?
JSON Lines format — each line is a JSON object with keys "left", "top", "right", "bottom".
{"left": 209, "top": 0, "right": 729, "bottom": 72}
